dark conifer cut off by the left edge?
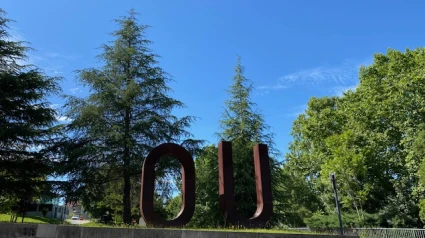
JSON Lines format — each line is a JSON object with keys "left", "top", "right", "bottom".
{"left": 0, "top": 9, "right": 60, "bottom": 221}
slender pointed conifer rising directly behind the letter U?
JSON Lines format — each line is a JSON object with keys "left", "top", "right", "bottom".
{"left": 218, "top": 57, "right": 277, "bottom": 217}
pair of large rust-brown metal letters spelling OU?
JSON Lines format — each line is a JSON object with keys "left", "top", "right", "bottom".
{"left": 140, "top": 141, "right": 273, "bottom": 228}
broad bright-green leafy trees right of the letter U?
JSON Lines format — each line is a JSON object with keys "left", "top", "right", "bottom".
{"left": 285, "top": 48, "right": 425, "bottom": 227}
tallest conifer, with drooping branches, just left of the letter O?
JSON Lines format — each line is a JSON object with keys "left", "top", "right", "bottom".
{"left": 59, "top": 10, "right": 198, "bottom": 224}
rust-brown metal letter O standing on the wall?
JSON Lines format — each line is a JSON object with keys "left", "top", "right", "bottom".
{"left": 140, "top": 143, "right": 195, "bottom": 227}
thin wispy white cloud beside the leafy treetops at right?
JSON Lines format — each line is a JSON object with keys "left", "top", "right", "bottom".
{"left": 257, "top": 60, "right": 370, "bottom": 95}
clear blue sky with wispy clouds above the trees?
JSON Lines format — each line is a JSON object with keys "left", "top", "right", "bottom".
{"left": 1, "top": 0, "right": 425, "bottom": 159}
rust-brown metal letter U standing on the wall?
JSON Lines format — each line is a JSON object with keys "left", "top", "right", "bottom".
{"left": 218, "top": 141, "right": 273, "bottom": 228}
